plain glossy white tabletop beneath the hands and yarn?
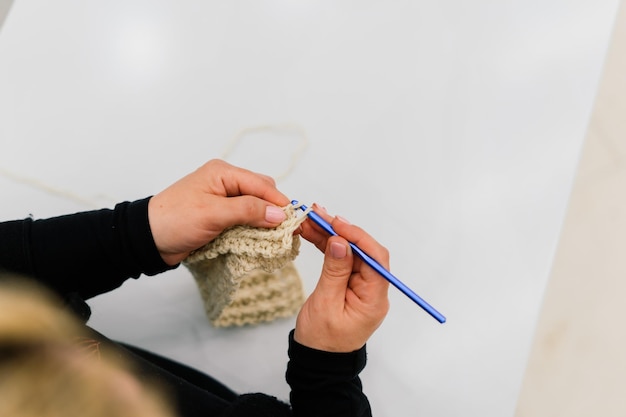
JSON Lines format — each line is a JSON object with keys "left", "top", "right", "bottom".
{"left": 0, "top": 0, "right": 618, "bottom": 417}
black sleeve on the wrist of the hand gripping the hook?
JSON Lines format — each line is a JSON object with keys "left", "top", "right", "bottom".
{"left": 286, "top": 330, "right": 372, "bottom": 417}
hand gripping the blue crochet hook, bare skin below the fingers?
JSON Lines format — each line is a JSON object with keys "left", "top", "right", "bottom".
{"left": 294, "top": 205, "right": 389, "bottom": 352}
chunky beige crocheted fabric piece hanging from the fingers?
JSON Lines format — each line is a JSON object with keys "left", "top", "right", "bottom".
{"left": 183, "top": 204, "right": 306, "bottom": 327}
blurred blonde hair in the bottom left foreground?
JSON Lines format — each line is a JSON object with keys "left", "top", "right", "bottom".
{"left": 0, "top": 274, "right": 173, "bottom": 417}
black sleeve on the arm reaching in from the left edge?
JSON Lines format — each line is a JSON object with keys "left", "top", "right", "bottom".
{"left": 0, "top": 198, "right": 172, "bottom": 299}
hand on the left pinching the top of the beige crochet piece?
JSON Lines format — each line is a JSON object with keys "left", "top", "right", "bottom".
{"left": 148, "top": 159, "right": 289, "bottom": 265}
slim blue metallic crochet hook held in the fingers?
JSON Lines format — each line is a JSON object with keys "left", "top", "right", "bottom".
{"left": 291, "top": 200, "right": 446, "bottom": 323}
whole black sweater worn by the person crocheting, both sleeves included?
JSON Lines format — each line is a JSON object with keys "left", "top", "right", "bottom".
{"left": 0, "top": 198, "right": 371, "bottom": 417}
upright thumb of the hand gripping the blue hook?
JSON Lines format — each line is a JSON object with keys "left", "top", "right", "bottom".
{"left": 318, "top": 236, "right": 353, "bottom": 300}
